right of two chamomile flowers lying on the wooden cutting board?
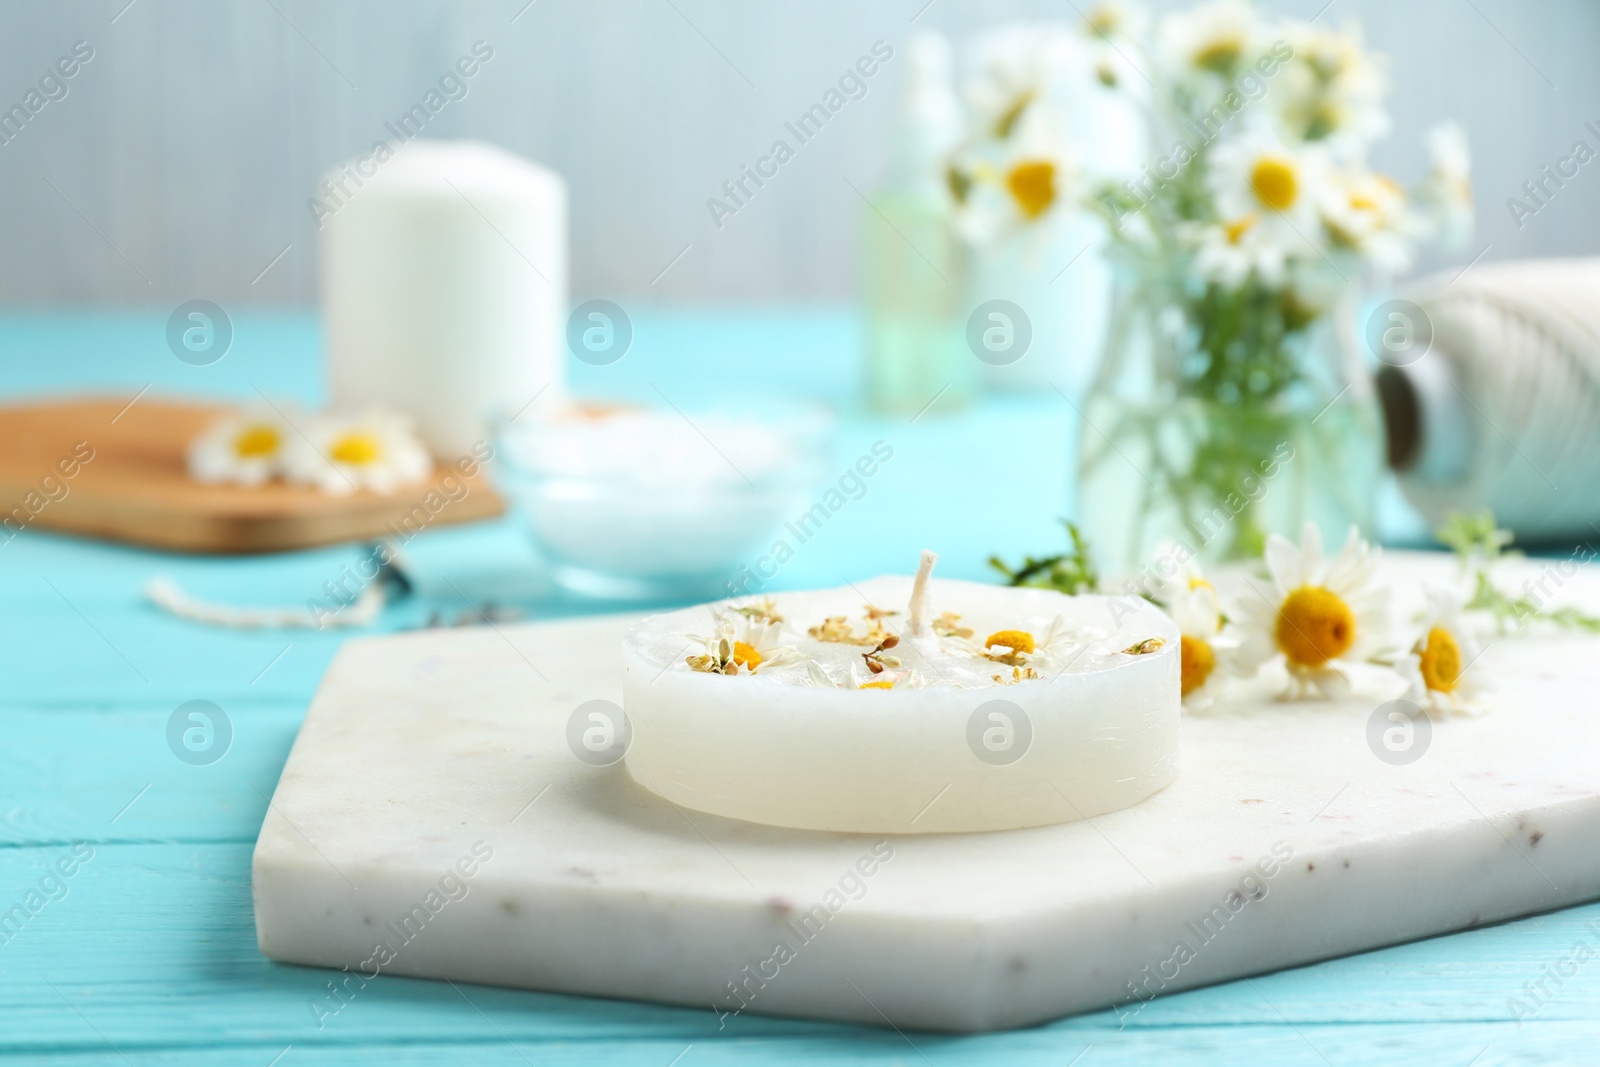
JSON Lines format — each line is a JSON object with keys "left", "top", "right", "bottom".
{"left": 283, "top": 411, "right": 434, "bottom": 494}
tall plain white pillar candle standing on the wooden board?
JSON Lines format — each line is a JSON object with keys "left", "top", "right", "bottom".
{"left": 320, "top": 141, "right": 566, "bottom": 456}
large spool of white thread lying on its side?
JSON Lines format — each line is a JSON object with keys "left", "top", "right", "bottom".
{"left": 1378, "top": 258, "right": 1600, "bottom": 542}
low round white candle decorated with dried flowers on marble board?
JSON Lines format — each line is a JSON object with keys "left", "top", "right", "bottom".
{"left": 622, "top": 553, "right": 1181, "bottom": 833}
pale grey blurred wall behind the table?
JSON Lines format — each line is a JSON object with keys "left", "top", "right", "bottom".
{"left": 0, "top": 0, "right": 1600, "bottom": 304}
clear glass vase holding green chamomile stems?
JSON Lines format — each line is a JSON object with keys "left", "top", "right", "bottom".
{"left": 1077, "top": 262, "right": 1382, "bottom": 577}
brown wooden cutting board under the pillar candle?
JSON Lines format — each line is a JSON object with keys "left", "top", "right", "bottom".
{"left": 0, "top": 397, "right": 506, "bottom": 553}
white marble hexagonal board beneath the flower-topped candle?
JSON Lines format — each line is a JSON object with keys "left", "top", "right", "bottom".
{"left": 254, "top": 557, "right": 1600, "bottom": 1030}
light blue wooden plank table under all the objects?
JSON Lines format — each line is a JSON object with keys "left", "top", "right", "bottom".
{"left": 0, "top": 303, "right": 1600, "bottom": 1067}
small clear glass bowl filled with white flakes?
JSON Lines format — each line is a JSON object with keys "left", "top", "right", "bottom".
{"left": 496, "top": 403, "right": 834, "bottom": 601}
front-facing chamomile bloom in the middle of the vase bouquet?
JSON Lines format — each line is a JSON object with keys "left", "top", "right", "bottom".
{"left": 1206, "top": 133, "right": 1326, "bottom": 254}
